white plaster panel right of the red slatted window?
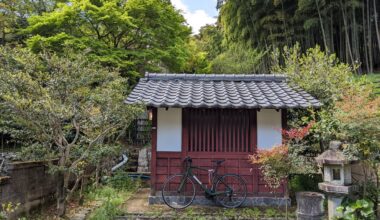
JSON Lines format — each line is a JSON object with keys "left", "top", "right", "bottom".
{"left": 257, "top": 109, "right": 282, "bottom": 149}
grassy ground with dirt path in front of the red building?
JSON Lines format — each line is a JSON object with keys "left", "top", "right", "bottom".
{"left": 26, "top": 186, "right": 295, "bottom": 220}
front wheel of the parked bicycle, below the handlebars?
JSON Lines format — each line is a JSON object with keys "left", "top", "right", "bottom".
{"left": 162, "top": 174, "right": 195, "bottom": 209}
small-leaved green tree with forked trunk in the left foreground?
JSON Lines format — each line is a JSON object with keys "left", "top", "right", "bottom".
{"left": 0, "top": 47, "right": 141, "bottom": 216}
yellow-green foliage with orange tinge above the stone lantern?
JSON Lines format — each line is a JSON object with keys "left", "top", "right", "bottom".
{"left": 273, "top": 45, "right": 380, "bottom": 217}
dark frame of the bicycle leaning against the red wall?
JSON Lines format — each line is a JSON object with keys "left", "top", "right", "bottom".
{"left": 178, "top": 162, "right": 232, "bottom": 196}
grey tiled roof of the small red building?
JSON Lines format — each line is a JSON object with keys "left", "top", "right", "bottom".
{"left": 125, "top": 73, "right": 321, "bottom": 108}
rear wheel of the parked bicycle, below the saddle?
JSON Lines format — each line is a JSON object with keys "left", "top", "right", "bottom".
{"left": 215, "top": 174, "right": 247, "bottom": 208}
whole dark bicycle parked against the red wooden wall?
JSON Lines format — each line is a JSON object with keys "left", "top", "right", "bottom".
{"left": 162, "top": 157, "right": 247, "bottom": 209}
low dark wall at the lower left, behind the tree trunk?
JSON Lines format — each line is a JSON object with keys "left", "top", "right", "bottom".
{"left": 0, "top": 162, "right": 57, "bottom": 215}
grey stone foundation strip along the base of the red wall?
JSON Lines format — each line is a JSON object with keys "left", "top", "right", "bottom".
{"left": 148, "top": 195, "right": 291, "bottom": 207}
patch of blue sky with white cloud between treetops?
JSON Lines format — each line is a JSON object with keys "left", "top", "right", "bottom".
{"left": 171, "top": 0, "right": 218, "bottom": 34}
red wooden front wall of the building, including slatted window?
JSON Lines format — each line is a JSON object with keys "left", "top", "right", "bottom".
{"left": 151, "top": 109, "right": 286, "bottom": 196}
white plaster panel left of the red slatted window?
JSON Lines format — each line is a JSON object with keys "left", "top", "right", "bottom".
{"left": 157, "top": 108, "right": 182, "bottom": 152}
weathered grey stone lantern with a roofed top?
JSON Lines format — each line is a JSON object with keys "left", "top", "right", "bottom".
{"left": 315, "top": 141, "right": 357, "bottom": 219}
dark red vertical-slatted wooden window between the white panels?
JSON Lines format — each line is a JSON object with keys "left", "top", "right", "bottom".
{"left": 183, "top": 109, "right": 256, "bottom": 153}
